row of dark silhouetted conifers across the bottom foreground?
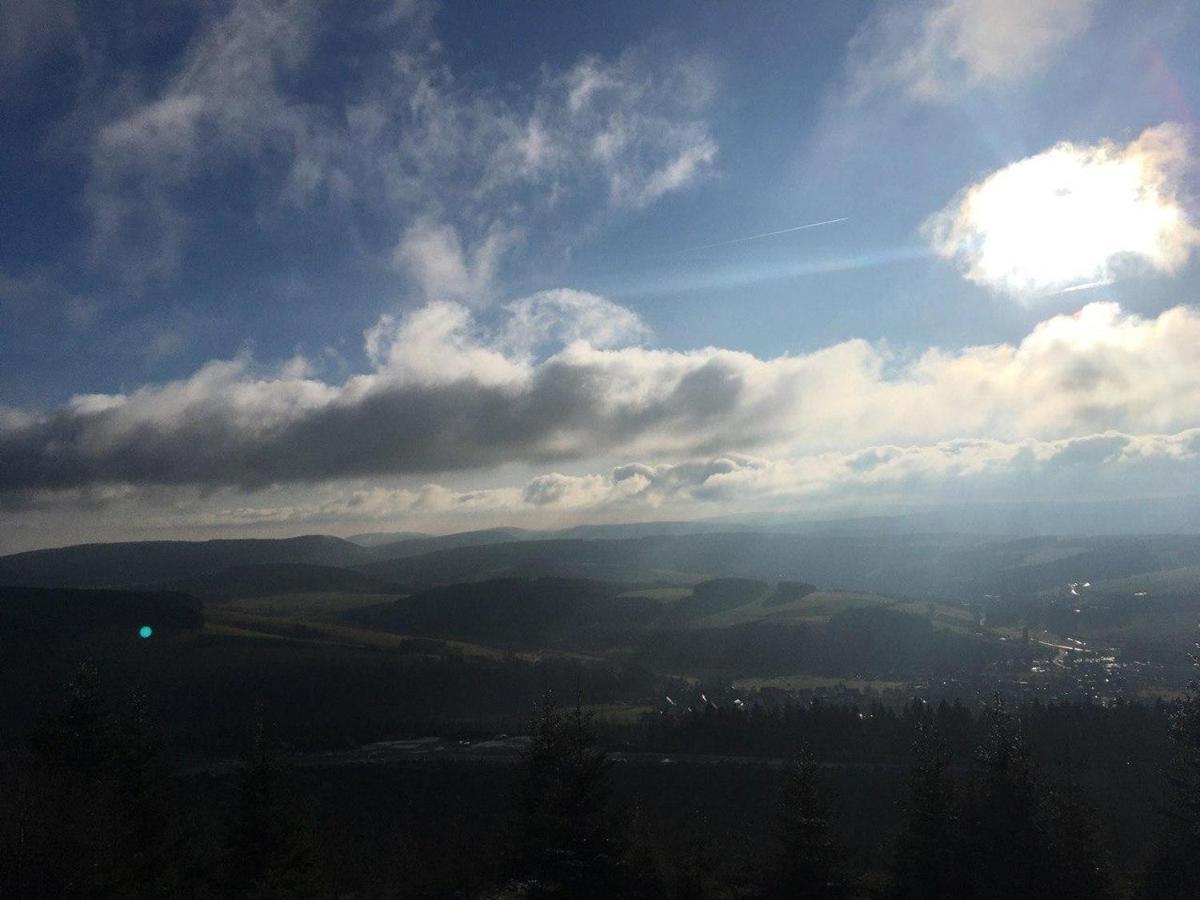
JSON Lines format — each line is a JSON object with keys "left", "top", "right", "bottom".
{"left": 7, "top": 664, "right": 1200, "bottom": 900}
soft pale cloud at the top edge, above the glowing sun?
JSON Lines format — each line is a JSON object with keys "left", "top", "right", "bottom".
{"left": 850, "top": 0, "right": 1097, "bottom": 101}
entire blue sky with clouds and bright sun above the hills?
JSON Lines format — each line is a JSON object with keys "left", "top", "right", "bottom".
{"left": 0, "top": 0, "right": 1200, "bottom": 552}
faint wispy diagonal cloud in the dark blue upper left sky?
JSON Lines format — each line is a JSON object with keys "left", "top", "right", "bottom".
{"left": 85, "top": 0, "right": 314, "bottom": 286}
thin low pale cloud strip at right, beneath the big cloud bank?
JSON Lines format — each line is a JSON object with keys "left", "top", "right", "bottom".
{"left": 501, "top": 428, "right": 1200, "bottom": 511}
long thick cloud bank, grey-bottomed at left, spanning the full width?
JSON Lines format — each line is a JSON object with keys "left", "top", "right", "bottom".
{"left": 0, "top": 300, "right": 1200, "bottom": 504}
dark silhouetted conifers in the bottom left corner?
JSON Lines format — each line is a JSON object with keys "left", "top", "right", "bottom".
{"left": 0, "top": 661, "right": 319, "bottom": 898}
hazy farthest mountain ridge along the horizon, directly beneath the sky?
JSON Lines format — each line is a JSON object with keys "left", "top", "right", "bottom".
{"left": 0, "top": 526, "right": 1200, "bottom": 599}
